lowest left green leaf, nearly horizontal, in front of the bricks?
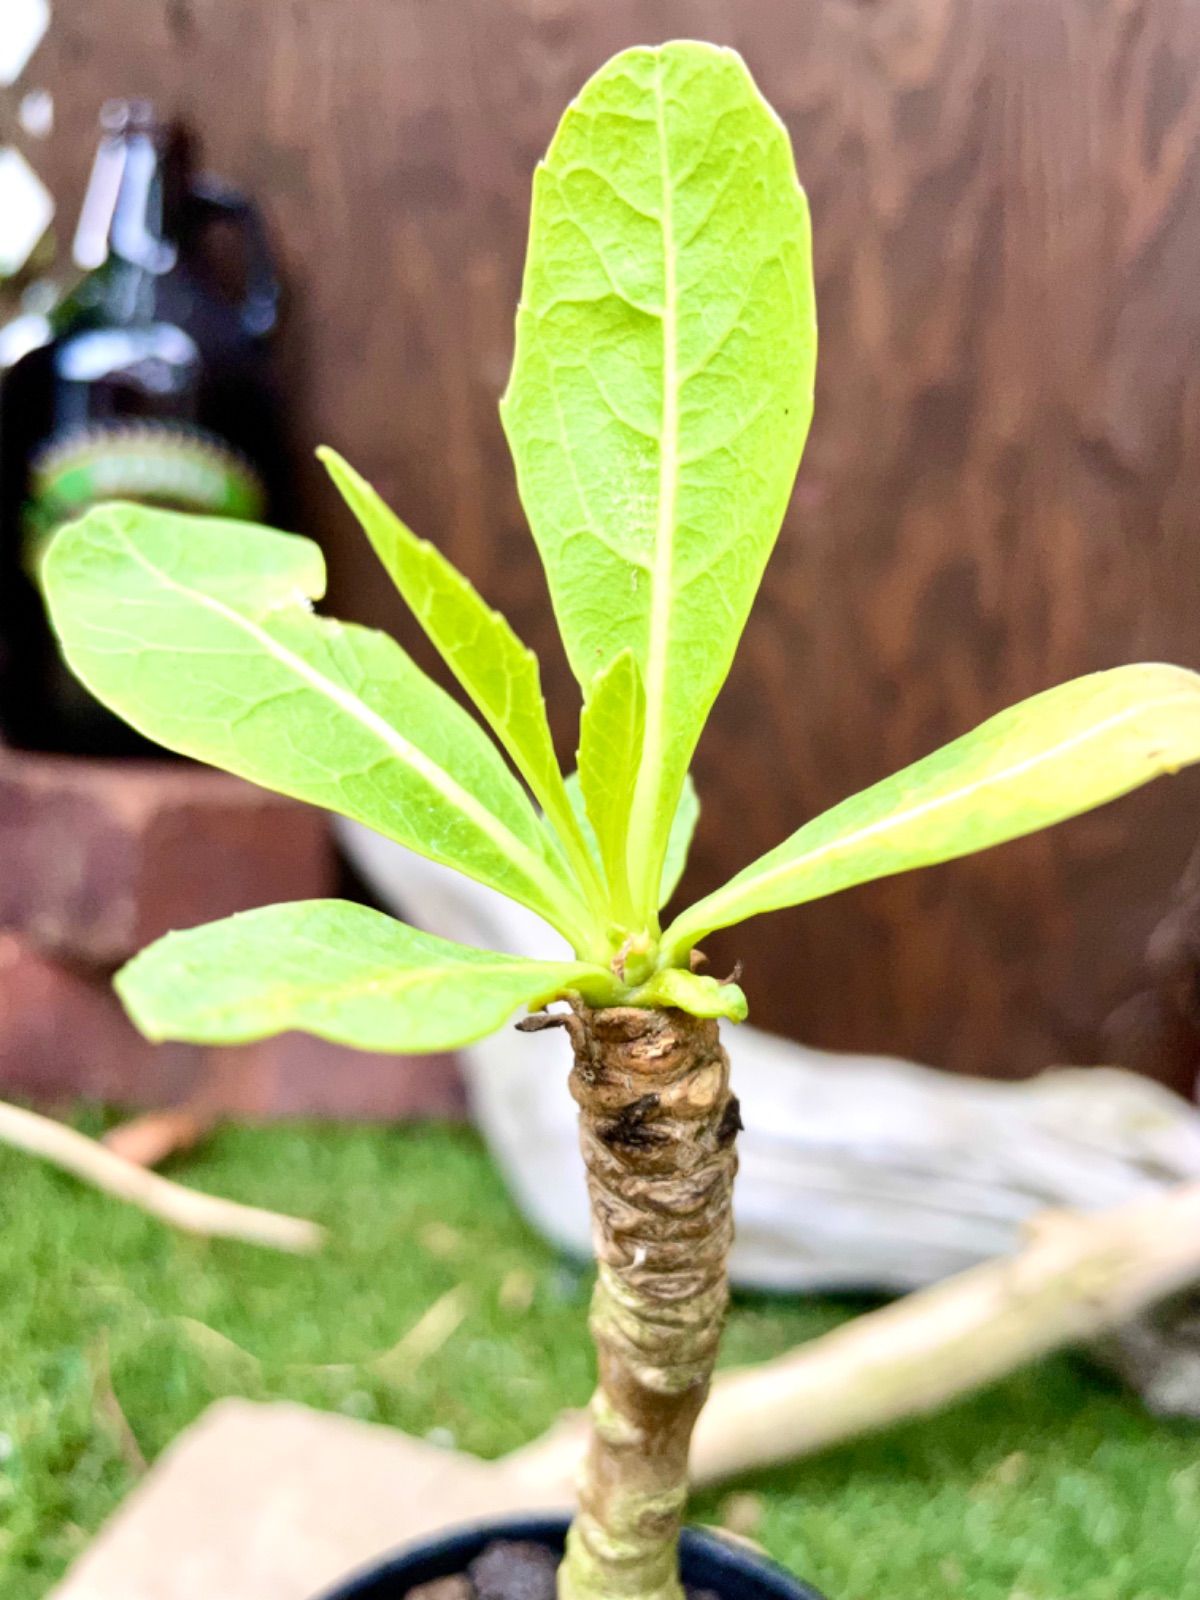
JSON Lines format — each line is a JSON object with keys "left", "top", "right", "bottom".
{"left": 117, "top": 901, "right": 616, "bottom": 1051}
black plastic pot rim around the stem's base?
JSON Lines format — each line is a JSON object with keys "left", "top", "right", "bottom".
{"left": 315, "top": 1517, "right": 824, "bottom": 1600}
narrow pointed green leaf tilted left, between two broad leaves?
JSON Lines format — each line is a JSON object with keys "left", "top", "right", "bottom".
{"left": 317, "top": 445, "right": 598, "bottom": 915}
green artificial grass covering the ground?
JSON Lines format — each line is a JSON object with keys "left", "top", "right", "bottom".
{"left": 0, "top": 1126, "right": 1200, "bottom": 1600}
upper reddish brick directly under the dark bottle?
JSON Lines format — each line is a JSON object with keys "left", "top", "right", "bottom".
{"left": 0, "top": 750, "right": 334, "bottom": 966}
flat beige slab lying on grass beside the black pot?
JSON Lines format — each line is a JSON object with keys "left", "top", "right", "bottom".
{"left": 48, "top": 1400, "right": 560, "bottom": 1600}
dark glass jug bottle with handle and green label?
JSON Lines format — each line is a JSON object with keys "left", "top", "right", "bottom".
{"left": 0, "top": 101, "right": 286, "bottom": 755}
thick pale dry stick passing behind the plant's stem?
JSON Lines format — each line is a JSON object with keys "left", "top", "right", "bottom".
{"left": 507, "top": 1182, "right": 1200, "bottom": 1499}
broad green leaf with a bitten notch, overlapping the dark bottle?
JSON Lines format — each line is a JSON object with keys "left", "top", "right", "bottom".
{"left": 43, "top": 506, "right": 590, "bottom": 947}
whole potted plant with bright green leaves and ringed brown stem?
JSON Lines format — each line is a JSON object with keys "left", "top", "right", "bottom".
{"left": 45, "top": 34, "right": 1200, "bottom": 1600}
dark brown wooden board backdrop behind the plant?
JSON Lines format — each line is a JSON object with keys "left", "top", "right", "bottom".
{"left": 27, "top": 0, "right": 1200, "bottom": 1086}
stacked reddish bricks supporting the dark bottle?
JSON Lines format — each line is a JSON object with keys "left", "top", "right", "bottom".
{"left": 0, "top": 750, "right": 462, "bottom": 1120}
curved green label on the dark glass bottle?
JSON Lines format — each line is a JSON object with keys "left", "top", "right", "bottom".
{"left": 24, "top": 422, "right": 266, "bottom": 578}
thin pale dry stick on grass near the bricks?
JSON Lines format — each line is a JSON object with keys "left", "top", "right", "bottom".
{"left": 0, "top": 1101, "right": 325, "bottom": 1253}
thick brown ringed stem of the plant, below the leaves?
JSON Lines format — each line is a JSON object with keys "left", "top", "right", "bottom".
{"left": 558, "top": 1005, "right": 741, "bottom": 1600}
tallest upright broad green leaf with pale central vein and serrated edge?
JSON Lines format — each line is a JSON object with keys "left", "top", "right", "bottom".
{"left": 502, "top": 43, "right": 816, "bottom": 922}
